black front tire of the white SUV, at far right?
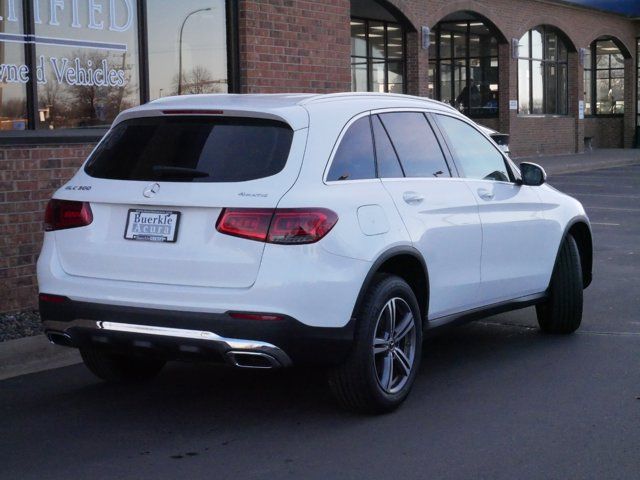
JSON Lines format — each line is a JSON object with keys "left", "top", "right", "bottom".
{"left": 536, "top": 235, "right": 583, "bottom": 334}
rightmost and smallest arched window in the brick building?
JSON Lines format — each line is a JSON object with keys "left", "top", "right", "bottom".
{"left": 584, "top": 38, "right": 624, "bottom": 115}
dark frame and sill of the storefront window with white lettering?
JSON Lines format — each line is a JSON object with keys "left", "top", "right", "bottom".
{"left": 0, "top": 0, "right": 240, "bottom": 145}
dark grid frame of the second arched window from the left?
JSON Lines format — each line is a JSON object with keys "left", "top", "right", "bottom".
{"left": 429, "top": 20, "right": 500, "bottom": 118}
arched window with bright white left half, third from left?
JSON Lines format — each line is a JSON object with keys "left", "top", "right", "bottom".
{"left": 518, "top": 26, "right": 568, "bottom": 115}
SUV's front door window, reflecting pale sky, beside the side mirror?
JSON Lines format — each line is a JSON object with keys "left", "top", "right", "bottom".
{"left": 438, "top": 115, "right": 510, "bottom": 182}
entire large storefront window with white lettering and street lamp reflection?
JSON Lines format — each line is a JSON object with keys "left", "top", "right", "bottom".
{"left": 0, "top": 0, "right": 237, "bottom": 136}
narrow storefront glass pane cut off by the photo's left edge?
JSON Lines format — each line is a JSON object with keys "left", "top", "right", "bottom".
{"left": 0, "top": 2, "right": 29, "bottom": 131}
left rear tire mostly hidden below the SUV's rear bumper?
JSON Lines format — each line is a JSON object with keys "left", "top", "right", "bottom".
{"left": 80, "top": 348, "right": 166, "bottom": 383}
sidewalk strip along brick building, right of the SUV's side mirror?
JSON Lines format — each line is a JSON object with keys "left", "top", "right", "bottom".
{"left": 513, "top": 148, "right": 640, "bottom": 175}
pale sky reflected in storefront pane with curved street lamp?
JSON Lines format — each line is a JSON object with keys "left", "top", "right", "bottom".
{"left": 147, "top": 0, "right": 227, "bottom": 99}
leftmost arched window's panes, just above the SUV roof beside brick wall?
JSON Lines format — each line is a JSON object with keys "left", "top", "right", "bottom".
{"left": 351, "top": 18, "right": 406, "bottom": 93}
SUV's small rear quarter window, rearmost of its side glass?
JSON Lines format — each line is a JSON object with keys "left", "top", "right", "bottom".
{"left": 327, "top": 116, "right": 376, "bottom": 181}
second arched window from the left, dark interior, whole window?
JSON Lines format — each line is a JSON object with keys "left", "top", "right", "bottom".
{"left": 429, "top": 15, "right": 499, "bottom": 117}
